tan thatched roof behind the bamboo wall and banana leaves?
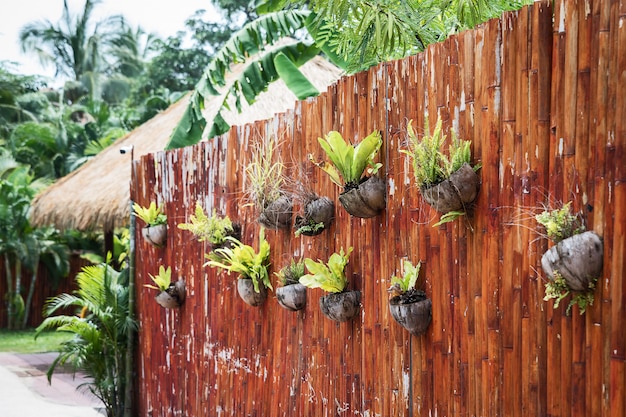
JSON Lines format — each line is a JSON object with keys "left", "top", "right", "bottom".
{"left": 30, "top": 57, "right": 341, "bottom": 231}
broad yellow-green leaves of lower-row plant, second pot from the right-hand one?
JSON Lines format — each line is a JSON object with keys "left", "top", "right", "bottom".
{"left": 299, "top": 247, "right": 353, "bottom": 293}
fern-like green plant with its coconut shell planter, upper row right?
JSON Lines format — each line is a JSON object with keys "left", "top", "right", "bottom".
{"left": 402, "top": 118, "right": 480, "bottom": 226}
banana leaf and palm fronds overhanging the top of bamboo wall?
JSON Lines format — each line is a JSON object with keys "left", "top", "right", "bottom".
{"left": 168, "top": 0, "right": 532, "bottom": 149}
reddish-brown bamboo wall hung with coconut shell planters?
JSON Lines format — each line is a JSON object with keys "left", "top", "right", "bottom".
{"left": 131, "top": 1, "right": 626, "bottom": 417}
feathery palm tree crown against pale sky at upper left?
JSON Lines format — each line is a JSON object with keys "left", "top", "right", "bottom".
{"left": 19, "top": 0, "right": 123, "bottom": 81}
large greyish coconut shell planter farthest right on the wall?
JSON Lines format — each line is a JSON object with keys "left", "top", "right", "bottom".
{"left": 541, "top": 231, "right": 604, "bottom": 291}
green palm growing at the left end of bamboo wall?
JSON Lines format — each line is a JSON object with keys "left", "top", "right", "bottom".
{"left": 36, "top": 263, "right": 136, "bottom": 417}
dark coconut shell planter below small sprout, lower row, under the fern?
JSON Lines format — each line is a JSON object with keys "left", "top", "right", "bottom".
{"left": 389, "top": 289, "right": 432, "bottom": 336}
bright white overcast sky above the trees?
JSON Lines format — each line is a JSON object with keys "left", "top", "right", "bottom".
{"left": 0, "top": 0, "right": 217, "bottom": 76}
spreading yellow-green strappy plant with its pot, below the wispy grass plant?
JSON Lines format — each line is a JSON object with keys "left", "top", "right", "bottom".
{"left": 205, "top": 229, "right": 273, "bottom": 307}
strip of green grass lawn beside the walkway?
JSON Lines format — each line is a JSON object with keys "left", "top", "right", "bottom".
{"left": 0, "top": 329, "right": 72, "bottom": 353}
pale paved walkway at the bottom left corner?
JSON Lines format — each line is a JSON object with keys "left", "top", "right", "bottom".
{"left": 0, "top": 353, "right": 105, "bottom": 417}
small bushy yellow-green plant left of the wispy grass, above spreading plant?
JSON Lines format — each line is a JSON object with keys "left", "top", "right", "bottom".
{"left": 178, "top": 202, "right": 241, "bottom": 250}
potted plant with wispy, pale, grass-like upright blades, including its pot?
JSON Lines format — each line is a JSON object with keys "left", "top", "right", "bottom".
{"left": 245, "top": 140, "right": 293, "bottom": 229}
